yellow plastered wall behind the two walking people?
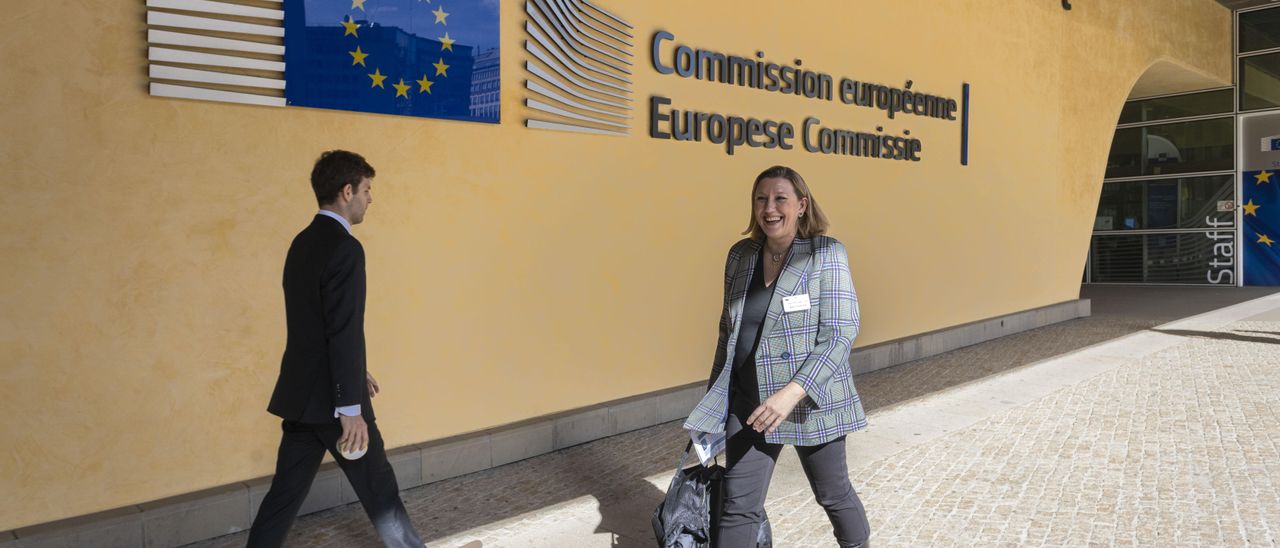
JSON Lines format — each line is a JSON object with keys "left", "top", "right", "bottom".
{"left": 0, "top": 0, "right": 1231, "bottom": 530}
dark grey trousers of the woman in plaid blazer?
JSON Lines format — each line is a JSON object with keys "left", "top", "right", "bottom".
{"left": 716, "top": 398, "right": 870, "bottom": 548}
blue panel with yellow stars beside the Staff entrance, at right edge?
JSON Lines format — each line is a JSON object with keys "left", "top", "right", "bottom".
{"left": 1240, "top": 169, "right": 1280, "bottom": 286}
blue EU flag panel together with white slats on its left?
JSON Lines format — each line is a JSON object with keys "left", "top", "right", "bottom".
{"left": 147, "top": 0, "right": 500, "bottom": 123}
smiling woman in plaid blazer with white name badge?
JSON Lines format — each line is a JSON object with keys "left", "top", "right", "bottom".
{"left": 685, "top": 165, "right": 869, "bottom": 548}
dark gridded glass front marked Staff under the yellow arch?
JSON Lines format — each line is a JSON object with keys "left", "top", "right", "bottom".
{"left": 1084, "top": 88, "right": 1236, "bottom": 286}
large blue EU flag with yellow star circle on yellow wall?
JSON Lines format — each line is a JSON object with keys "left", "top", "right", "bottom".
{"left": 284, "top": 0, "right": 499, "bottom": 123}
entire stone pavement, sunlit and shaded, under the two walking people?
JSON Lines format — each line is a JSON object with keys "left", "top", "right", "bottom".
{"left": 189, "top": 287, "right": 1280, "bottom": 547}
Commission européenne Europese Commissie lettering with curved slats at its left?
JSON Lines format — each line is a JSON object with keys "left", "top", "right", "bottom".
{"left": 525, "top": 0, "right": 969, "bottom": 165}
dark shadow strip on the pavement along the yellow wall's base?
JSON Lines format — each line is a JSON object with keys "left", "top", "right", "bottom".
{"left": 185, "top": 286, "right": 1280, "bottom": 548}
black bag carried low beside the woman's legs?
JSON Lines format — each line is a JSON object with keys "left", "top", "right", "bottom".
{"left": 653, "top": 442, "right": 773, "bottom": 548}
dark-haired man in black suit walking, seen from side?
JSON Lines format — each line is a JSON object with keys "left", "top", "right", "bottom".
{"left": 248, "top": 150, "right": 422, "bottom": 548}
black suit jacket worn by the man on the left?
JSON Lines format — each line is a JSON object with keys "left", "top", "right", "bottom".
{"left": 266, "top": 215, "right": 374, "bottom": 424}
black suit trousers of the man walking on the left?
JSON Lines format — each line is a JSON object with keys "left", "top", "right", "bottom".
{"left": 248, "top": 420, "right": 422, "bottom": 548}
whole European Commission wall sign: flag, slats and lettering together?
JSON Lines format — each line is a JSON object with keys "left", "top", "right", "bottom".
{"left": 147, "top": 0, "right": 967, "bottom": 165}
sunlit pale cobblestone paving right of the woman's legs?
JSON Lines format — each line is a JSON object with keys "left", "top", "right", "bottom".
{"left": 839, "top": 318, "right": 1280, "bottom": 547}
